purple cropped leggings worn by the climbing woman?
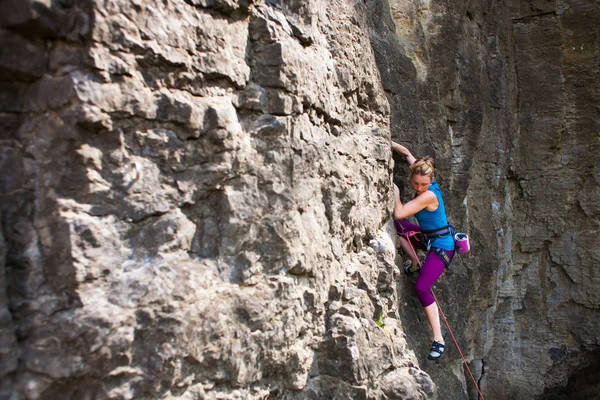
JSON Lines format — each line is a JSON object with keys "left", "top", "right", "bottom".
{"left": 394, "top": 221, "right": 454, "bottom": 307}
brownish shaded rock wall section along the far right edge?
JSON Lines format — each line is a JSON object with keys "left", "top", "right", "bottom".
{"left": 488, "top": 1, "right": 600, "bottom": 399}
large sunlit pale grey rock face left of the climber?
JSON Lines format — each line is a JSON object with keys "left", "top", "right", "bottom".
{"left": 0, "top": 0, "right": 435, "bottom": 399}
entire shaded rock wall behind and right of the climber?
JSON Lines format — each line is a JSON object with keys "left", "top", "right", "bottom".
{"left": 371, "top": 0, "right": 600, "bottom": 399}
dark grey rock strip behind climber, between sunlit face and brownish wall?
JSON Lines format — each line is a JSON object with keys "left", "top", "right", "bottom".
{"left": 371, "top": 0, "right": 518, "bottom": 399}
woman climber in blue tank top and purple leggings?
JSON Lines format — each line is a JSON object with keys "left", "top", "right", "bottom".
{"left": 392, "top": 142, "right": 454, "bottom": 360}
